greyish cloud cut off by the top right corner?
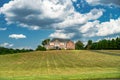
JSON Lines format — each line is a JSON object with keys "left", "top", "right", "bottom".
{"left": 86, "top": 0, "right": 120, "bottom": 6}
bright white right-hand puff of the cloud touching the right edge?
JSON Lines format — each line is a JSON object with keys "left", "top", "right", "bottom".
{"left": 96, "top": 18, "right": 120, "bottom": 36}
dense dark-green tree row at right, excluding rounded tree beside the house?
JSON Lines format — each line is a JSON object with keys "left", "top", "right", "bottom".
{"left": 85, "top": 38, "right": 120, "bottom": 50}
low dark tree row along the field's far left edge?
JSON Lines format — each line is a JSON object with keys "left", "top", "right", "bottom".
{"left": 0, "top": 47, "right": 33, "bottom": 54}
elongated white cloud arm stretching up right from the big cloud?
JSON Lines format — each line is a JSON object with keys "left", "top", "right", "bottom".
{"left": 54, "top": 9, "right": 104, "bottom": 28}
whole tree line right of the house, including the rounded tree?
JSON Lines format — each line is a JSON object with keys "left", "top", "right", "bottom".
{"left": 75, "top": 37, "right": 120, "bottom": 50}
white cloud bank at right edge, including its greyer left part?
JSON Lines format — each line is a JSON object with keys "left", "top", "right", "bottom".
{"left": 79, "top": 18, "right": 120, "bottom": 37}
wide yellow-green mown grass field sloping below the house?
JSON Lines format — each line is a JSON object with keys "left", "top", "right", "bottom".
{"left": 0, "top": 50, "right": 120, "bottom": 80}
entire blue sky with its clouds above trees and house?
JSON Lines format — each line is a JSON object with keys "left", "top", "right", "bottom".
{"left": 0, "top": 0, "right": 120, "bottom": 49}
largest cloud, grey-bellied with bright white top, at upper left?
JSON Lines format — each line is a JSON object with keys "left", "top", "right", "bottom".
{"left": 1, "top": 0, "right": 73, "bottom": 29}
